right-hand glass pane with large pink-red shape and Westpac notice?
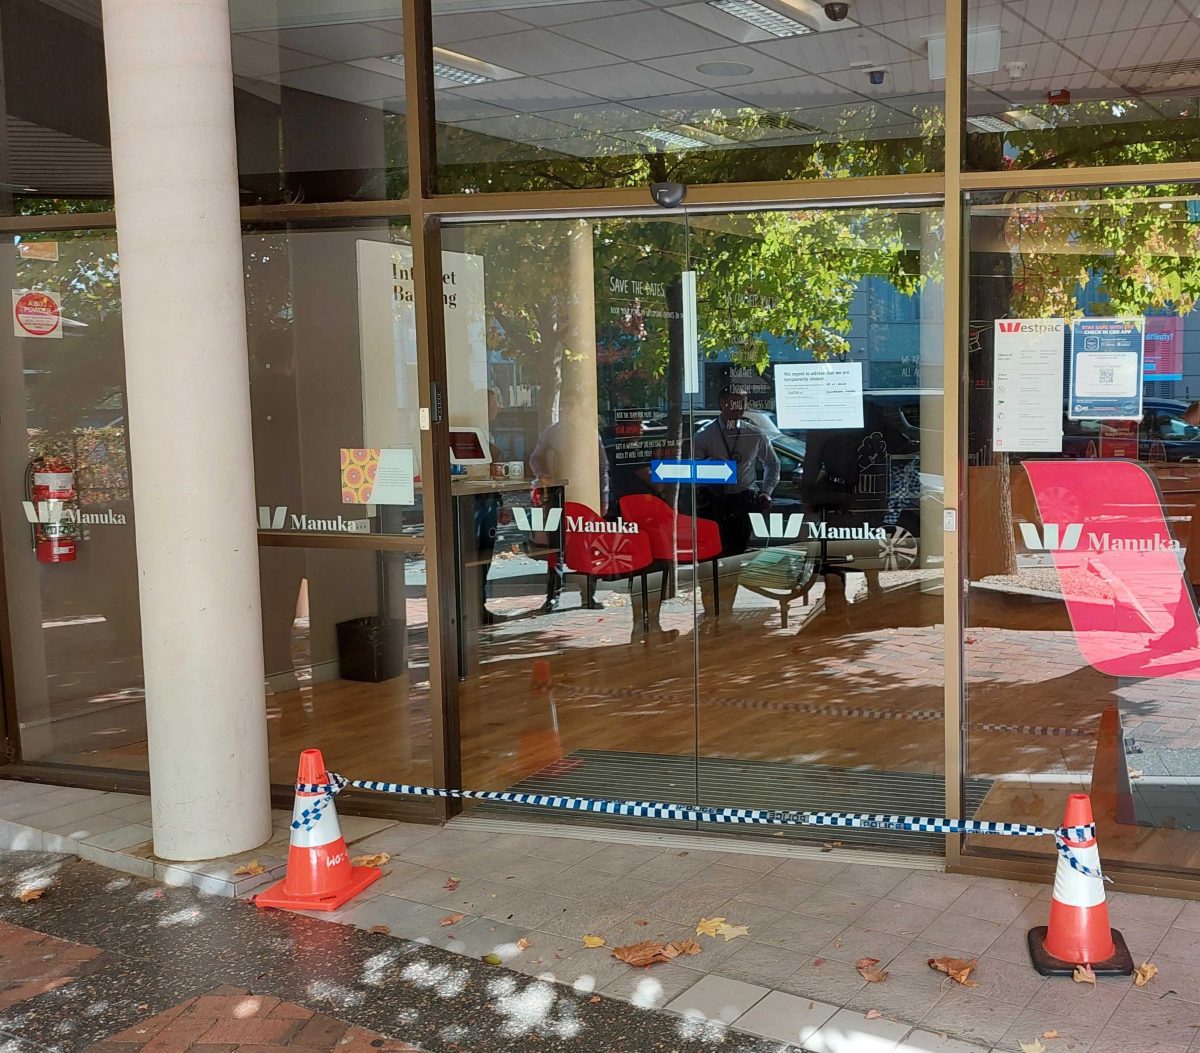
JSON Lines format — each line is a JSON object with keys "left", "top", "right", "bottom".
{"left": 965, "top": 186, "right": 1200, "bottom": 871}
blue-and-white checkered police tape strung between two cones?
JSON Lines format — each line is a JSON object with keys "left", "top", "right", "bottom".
{"left": 292, "top": 771, "right": 1110, "bottom": 880}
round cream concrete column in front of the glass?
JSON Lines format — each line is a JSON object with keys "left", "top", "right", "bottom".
{"left": 103, "top": 0, "right": 271, "bottom": 860}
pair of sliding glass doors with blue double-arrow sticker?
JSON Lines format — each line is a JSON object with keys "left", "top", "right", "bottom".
{"left": 443, "top": 207, "right": 944, "bottom": 852}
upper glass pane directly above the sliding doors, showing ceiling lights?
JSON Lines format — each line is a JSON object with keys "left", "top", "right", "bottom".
{"left": 433, "top": 0, "right": 944, "bottom": 193}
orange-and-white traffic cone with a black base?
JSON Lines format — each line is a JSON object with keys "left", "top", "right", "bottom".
{"left": 1028, "top": 794, "right": 1133, "bottom": 976}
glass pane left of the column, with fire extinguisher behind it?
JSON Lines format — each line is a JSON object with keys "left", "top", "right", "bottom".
{"left": 0, "top": 230, "right": 142, "bottom": 769}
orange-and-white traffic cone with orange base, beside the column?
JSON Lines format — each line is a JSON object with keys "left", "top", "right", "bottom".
{"left": 254, "top": 750, "right": 380, "bottom": 910}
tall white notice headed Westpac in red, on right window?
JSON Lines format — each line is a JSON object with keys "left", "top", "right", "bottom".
{"left": 991, "top": 318, "right": 1067, "bottom": 453}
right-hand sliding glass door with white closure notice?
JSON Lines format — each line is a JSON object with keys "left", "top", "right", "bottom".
{"left": 688, "top": 207, "right": 944, "bottom": 852}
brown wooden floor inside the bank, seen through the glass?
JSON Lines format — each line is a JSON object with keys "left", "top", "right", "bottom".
{"left": 30, "top": 577, "right": 1200, "bottom": 870}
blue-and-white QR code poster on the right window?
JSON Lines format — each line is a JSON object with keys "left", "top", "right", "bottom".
{"left": 1067, "top": 318, "right": 1146, "bottom": 421}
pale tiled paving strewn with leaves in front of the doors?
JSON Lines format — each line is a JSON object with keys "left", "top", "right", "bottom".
{"left": 0, "top": 777, "right": 1200, "bottom": 1053}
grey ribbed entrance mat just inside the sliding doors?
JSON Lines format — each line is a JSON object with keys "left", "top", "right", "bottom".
{"left": 473, "top": 750, "right": 991, "bottom": 854}
